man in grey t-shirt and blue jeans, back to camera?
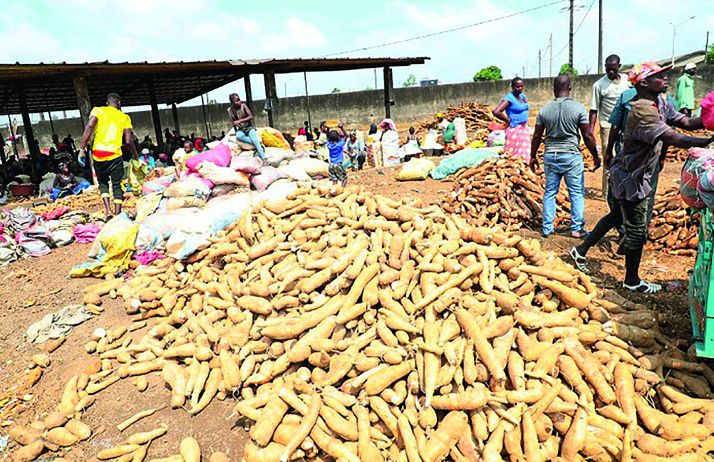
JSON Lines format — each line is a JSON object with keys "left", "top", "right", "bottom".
{"left": 530, "top": 75, "right": 600, "bottom": 238}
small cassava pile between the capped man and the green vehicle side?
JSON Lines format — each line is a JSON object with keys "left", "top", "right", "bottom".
{"left": 649, "top": 186, "right": 701, "bottom": 257}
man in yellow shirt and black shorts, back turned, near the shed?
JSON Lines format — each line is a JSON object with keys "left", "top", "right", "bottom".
{"left": 80, "top": 93, "right": 139, "bottom": 216}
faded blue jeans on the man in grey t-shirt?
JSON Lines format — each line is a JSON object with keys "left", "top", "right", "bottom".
{"left": 543, "top": 152, "right": 585, "bottom": 235}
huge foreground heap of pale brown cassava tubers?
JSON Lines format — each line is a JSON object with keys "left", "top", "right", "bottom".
{"left": 9, "top": 182, "right": 714, "bottom": 462}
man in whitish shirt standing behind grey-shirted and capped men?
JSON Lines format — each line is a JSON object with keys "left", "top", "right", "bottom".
{"left": 590, "top": 55, "right": 630, "bottom": 197}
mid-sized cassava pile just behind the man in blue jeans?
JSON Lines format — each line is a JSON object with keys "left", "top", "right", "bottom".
{"left": 442, "top": 157, "right": 570, "bottom": 230}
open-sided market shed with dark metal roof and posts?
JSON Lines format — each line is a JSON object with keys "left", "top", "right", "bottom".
{"left": 0, "top": 57, "right": 429, "bottom": 164}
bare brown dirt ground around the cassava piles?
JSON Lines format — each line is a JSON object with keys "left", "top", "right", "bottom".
{"left": 0, "top": 158, "right": 693, "bottom": 461}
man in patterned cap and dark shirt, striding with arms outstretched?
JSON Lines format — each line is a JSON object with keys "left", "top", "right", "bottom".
{"left": 570, "top": 62, "right": 714, "bottom": 294}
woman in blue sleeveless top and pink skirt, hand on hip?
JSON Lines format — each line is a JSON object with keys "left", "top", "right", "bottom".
{"left": 493, "top": 77, "right": 531, "bottom": 162}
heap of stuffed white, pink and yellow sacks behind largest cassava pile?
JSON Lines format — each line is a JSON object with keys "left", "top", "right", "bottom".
{"left": 71, "top": 137, "right": 328, "bottom": 270}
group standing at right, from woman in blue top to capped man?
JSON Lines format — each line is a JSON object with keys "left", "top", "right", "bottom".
{"left": 493, "top": 55, "right": 714, "bottom": 293}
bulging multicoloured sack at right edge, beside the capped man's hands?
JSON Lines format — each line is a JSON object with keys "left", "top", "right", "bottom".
{"left": 679, "top": 148, "right": 714, "bottom": 209}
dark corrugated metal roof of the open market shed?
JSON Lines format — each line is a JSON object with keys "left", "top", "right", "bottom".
{"left": 0, "top": 57, "right": 429, "bottom": 115}
